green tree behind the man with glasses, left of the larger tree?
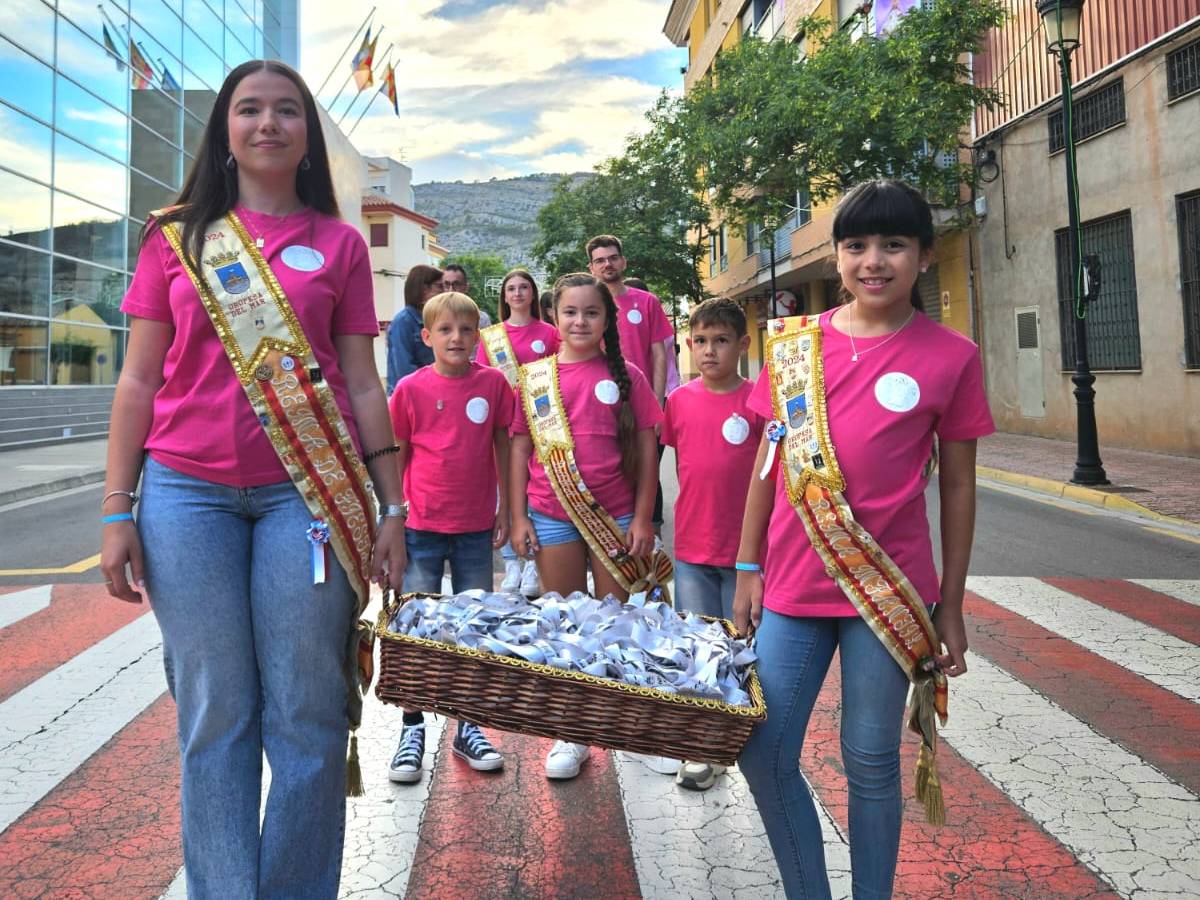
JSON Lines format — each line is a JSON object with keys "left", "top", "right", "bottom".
{"left": 533, "top": 94, "right": 708, "bottom": 302}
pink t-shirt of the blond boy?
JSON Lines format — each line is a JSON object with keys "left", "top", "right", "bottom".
{"left": 388, "top": 362, "right": 512, "bottom": 534}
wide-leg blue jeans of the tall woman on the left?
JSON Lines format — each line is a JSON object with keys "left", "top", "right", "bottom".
{"left": 138, "top": 457, "right": 356, "bottom": 900}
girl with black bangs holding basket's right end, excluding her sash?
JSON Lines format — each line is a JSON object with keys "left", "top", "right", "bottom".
{"left": 733, "top": 181, "right": 994, "bottom": 900}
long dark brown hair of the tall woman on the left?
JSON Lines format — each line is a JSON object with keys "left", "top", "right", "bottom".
{"left": 142, "top": 59, "right": 340, "bottom": 268}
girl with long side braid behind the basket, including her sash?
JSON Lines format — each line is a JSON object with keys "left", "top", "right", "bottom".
{"left": 509, "top": 274, "right": 662, "bottom": 779}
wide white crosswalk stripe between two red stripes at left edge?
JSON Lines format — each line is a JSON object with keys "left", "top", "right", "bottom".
{"left": 0, "top": 616, "right": 164, "bottom": 830}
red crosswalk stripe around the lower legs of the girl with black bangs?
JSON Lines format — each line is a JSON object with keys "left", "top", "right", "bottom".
{"left": 800, "top": 656, "right": 1116, "bottom": 900}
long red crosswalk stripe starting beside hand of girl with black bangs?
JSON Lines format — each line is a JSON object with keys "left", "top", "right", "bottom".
{"left": 966, "top": 588, "right": 1200, "bottom": 792}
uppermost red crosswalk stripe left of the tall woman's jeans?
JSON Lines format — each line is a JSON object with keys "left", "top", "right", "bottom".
{"left": 0, "top": 584, "right": 150, "bottom": 701}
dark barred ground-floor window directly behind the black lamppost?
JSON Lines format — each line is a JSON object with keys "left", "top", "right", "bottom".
{"left": 1054, "top": 210, "right": 1141, "bottom": 371}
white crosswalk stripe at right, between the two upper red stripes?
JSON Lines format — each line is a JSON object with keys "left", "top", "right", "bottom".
{"left": 967, "top": 576, "right": 1200, "bottom": 702}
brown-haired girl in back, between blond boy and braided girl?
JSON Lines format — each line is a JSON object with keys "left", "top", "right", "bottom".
{"left": 475, "top": 269, "right": 559, "bottom": 596}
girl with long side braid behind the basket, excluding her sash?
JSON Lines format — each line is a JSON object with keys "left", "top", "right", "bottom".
{"left": 509, "top": 274, "right": 662, "bottom": 779}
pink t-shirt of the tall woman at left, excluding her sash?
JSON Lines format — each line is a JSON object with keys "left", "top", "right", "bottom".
{"left": 121, "top": 208, "right": 379, "bottom": 487}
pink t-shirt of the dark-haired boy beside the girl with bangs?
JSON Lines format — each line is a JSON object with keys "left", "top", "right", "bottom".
{"left": 662, "top": 378, "right": 766, "bottom": 566}
